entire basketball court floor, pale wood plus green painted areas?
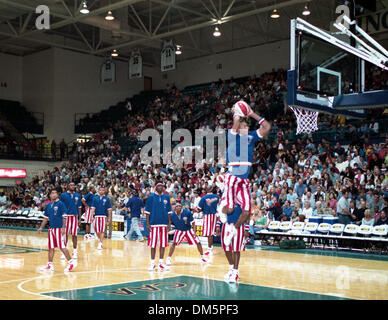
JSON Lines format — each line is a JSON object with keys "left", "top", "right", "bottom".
{"left": 0, "top": 229, "right": 388, "bottom": 300}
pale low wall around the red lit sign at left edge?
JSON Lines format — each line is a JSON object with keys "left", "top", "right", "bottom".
{"left": 0, "top": 159, "right": 62, "bottom": 187}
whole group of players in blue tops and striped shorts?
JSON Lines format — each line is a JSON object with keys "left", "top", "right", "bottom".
{"left": 38, "top": 100, "right": 270, "bottom": 282}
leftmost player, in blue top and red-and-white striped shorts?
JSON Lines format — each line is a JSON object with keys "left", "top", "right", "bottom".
{"left": 38, "top": 189, "right": 75, "bottom": 272}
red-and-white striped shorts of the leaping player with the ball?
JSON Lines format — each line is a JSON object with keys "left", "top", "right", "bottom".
{"left": 221, "top": 172, "right": 251, "bottom": 211}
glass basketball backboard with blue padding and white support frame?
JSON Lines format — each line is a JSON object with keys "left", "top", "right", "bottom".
{"left": 287, "top": 18, "right": 388, "bottom": 118}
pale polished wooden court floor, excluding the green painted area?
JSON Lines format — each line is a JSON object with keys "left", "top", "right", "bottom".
{"left": 0, "top": 229, "right": 388, "bottom": 300}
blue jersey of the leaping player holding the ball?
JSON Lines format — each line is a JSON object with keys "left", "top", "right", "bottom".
{"left": 226, "top": 130, "right": 262, "bottom": 179}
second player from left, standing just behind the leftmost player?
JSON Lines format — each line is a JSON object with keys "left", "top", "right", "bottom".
{"left": 59, "top": 182, "right": 82, "bottom": 259}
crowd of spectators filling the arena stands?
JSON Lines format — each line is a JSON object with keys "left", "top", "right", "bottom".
{"left": 0, "top": 70, "right": 388, "bottom": 244}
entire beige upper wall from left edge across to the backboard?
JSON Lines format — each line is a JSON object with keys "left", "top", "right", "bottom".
{"left": 0, "top": 41, "right": 289, "bottom": 142}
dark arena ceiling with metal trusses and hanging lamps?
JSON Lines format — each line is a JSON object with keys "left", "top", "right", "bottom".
{"left": 0, "top": 0, "right": 388, "bottom": 66}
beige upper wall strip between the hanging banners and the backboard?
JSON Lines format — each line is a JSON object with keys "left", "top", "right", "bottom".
{"left": 162, "top": 40, "right": 290, "bottom": 89}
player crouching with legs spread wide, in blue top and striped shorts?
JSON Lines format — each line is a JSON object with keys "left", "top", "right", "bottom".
{"left": 166, "top": 202, "right": 208, "bottom": 266}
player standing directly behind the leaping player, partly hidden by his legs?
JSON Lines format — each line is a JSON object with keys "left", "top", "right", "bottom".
{"left": 216, "top": 205, "right": 249, "bottom": 283}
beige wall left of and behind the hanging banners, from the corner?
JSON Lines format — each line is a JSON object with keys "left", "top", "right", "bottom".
{"left": 23, "top": 48, "right": 160, "bottom": 142}
